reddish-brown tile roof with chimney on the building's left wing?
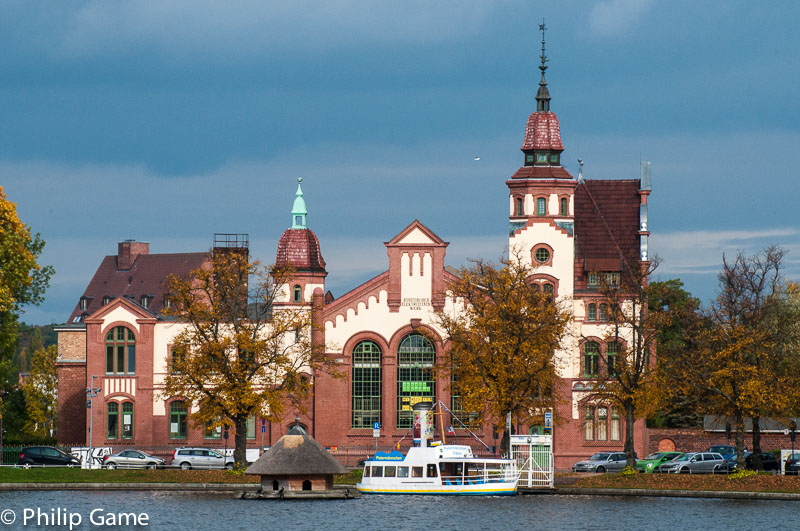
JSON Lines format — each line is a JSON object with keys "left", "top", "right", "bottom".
{"left": 67, "top": 253, "right": 208, "bottom": 323}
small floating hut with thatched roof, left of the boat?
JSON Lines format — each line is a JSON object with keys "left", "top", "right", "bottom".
{"left": 245, "top": 426, "right": 345, "bottom": 490}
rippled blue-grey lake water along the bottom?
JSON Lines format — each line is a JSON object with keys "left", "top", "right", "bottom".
{"left": 0, "top": 491, "right": 800, "bottom": 531}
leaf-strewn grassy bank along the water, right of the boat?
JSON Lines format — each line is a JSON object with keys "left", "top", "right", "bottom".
{"left": 570, "top": 473, "right": 800, "bottom": 494}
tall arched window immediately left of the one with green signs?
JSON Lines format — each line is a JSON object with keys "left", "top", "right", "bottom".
{"left": 350, "top": 341, "right": 382, "bottom": 428}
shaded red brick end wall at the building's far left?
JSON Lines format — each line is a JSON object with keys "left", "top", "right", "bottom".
{"left": 56, "top": 364, "right": 87, "bottom": 445}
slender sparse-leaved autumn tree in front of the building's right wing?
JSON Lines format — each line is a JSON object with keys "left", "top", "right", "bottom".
{"left": 585, "top": 257, "right": 669, "bottom": 467}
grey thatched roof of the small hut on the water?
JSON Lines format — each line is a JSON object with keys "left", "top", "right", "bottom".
{"left": 245, "top": 429, "right": 345, "bottom": 476}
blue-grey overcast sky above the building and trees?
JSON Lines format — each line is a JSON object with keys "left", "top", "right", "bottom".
{"left": 0, "top": 0, "right": 800, "bottom": 323}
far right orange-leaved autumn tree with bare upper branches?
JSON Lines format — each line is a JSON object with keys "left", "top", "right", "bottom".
{"left": 686, "top": 246, "right": 800, "bottom": 468}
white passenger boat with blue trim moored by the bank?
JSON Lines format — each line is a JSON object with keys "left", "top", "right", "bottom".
{"left": 356, "top": 445, "right": 519, "bottom": 496}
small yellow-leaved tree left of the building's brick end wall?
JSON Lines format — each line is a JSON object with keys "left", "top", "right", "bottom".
{"left": 22, "top": 345, "right": 58, "bottom": 437}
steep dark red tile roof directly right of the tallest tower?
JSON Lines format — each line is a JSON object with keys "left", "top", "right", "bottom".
{"left": 575, "top": 180, "right": 641, "bottom": 270}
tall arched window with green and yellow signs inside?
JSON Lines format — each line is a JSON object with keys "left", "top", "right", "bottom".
{"left": 397, "top": 334, "right": 436, "bottom": 428}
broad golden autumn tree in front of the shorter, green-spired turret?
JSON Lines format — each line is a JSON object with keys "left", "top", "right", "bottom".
{"left": 162, "top": 249, "right": 332, "bottom": 463}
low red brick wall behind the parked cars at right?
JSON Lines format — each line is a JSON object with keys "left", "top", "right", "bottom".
{"left": 648, "top": 428, "right": 800, "bottom": 453}
